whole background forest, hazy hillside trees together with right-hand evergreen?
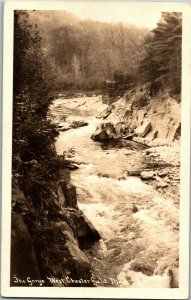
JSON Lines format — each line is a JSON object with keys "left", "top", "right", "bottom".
{"left": 29, "top": 11, "right": 182, "bottom": 92}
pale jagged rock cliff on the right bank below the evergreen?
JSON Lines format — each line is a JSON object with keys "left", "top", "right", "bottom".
{"left": 92, "top": 87, "right": 181, "bottom": 146}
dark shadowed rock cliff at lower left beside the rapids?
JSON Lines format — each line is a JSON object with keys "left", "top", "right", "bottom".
{"left": 10, "top": 172, "right": 100, "bottom": 286}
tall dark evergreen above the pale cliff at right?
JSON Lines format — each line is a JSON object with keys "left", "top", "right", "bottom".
{"left": 141, "top": 12, "right": 182, "bottom": 93}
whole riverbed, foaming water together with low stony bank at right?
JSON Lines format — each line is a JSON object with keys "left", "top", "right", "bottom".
{"left": 49, "top": 96, "right": 180, "bottom": 287}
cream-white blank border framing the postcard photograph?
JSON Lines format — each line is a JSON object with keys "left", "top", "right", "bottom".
{"left": 1, "top": 0, "right": 191, "bottom": 299}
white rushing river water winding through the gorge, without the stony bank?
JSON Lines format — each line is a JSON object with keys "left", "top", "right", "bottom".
{"left": 51, "top": 99, "right": 178, "bottom": 288}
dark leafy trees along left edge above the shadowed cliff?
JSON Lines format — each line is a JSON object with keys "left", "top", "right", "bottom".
{"left": 13, "top": 11, "right": 57, "bottom": 174}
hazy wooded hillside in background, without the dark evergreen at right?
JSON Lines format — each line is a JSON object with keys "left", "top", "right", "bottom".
{"left": 31, "top": 11, "right": 147, "bottom": 90}
